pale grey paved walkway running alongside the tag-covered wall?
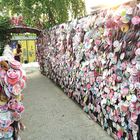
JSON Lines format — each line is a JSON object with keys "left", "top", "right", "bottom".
{"left": 21, "top": 72, "right": 112, "bottom": 140}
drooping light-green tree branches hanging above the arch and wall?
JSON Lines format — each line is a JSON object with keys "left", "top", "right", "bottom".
{"left": 0, "top": 0, "right": 85, "bottom": 28}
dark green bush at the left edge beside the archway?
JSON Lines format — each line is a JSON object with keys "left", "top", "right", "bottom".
{"left": 0, "top": 16, "right": 10, "bottom": 56}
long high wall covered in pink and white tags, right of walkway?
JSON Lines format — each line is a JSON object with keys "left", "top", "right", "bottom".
{"left": 37, "top": 5, "right": 140, "bottom": 140}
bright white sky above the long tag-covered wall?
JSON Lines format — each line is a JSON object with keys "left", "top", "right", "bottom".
{"left": 85, "top": 0, "right": 133, "bottom": 14}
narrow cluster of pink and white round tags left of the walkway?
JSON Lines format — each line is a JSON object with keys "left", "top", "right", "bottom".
{"left": 0, "top": 45, "right": 26, "bottom": 140}
